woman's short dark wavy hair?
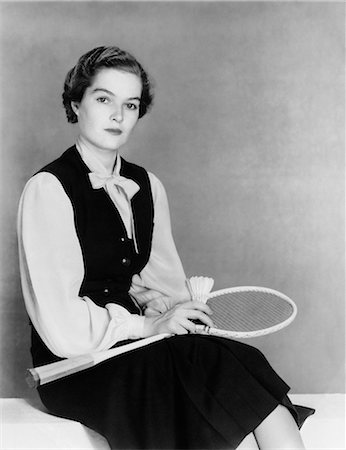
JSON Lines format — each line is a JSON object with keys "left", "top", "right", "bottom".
{"left": 62, "top": 46, "right": 153, "bottom": 123}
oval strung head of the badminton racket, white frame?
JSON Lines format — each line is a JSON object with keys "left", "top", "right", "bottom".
{"left": 203, "top": 286, "right": 297, "bottom": 338}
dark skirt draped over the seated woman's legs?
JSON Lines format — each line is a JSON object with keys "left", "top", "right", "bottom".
{"left": 35, "top": 334, "right": 314, "bottom": 450}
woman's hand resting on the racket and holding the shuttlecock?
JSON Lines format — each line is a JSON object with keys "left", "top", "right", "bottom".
{"left": 143, "top": 301, "right": 213, "bottom": 337}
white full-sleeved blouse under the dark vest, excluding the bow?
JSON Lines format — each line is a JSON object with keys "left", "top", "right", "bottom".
{"left": 18, "top": 147, "right": 190, "bottom": 358}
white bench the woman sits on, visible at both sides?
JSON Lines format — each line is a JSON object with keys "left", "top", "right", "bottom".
{"left": 0, "top": 394, "right": 346, "bottom": 450}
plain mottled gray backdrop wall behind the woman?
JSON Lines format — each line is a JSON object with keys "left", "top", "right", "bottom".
{"left": 0, "top": 2, "right": 345, "bottom": 397}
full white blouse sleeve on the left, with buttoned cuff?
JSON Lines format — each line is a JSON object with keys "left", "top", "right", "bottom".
{"left": 18, "top": 173, "right": 144, "bottom": 358}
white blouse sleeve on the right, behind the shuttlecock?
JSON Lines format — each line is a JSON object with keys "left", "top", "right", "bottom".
{"left": 130, "top": 172, "right": 190, "bottom": 312}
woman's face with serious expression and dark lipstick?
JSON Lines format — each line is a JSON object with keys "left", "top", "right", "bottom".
{"left": 72, "top": 68, "right": 142, "bottom": 151}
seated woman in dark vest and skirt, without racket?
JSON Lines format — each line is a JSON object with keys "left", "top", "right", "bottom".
{"left": 18, "top": 47, "right": 312, "bottom": 449}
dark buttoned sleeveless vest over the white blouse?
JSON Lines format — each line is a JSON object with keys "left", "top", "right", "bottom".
{"left": 33, "top": 146, "right": 154, "bottom": 368}
